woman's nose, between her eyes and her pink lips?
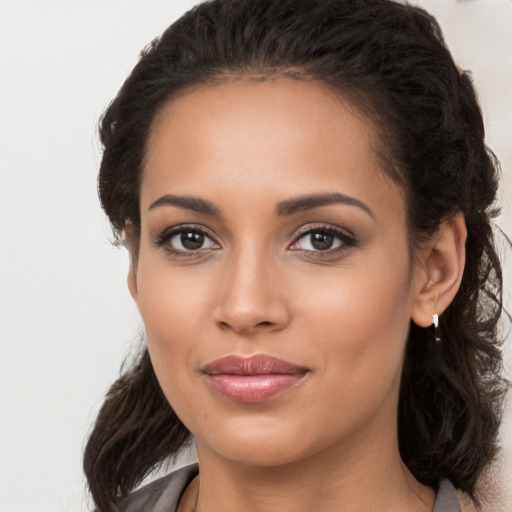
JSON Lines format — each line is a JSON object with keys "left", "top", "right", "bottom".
{"left": 214, "top": 249, "right": 290, "bottom": 335}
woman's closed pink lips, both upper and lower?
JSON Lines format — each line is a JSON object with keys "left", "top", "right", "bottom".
{"left": 201, "top": 354, "right": 309, "bottom": 403}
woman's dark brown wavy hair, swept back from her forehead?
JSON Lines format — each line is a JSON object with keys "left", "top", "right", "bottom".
{"left": 84, "top": 0, "right": 506, "bottom": 512}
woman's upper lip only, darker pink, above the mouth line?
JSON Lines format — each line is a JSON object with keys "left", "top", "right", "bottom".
{"left": 202, "top": 354, "right": 308, "bottom": 375}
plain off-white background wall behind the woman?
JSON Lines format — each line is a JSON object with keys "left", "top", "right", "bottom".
{"left": 0, "top": 0, "right": 512, "bottom": 512}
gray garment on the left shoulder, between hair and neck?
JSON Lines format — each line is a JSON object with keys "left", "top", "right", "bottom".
{"left": 119, "top": 464, "right": 199, "bottom": 512}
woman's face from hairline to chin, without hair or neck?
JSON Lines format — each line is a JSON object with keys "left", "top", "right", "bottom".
{"left": 129, "top": 79, "right": 424, "bottom": 465}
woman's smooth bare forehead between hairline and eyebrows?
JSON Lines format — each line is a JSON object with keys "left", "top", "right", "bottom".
{"left": 141, "top": 78, "right": 403, "bottom": 222}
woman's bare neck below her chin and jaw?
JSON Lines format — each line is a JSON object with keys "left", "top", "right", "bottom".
{"left": 186, "top": 426, "right": 435, "bottom": 512}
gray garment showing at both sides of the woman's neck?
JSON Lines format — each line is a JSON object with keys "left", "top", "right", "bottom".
{"left": 120, "top": 464, "right": 460, "bottom": 512}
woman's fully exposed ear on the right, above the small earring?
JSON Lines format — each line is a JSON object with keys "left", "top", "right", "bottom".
{"left": 411, "top": 212, "right": 467, "bottom": 327}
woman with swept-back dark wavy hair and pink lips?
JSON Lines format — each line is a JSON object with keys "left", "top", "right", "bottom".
{"left": 85, "top": 0, "right": 505, "bottom": 512}
